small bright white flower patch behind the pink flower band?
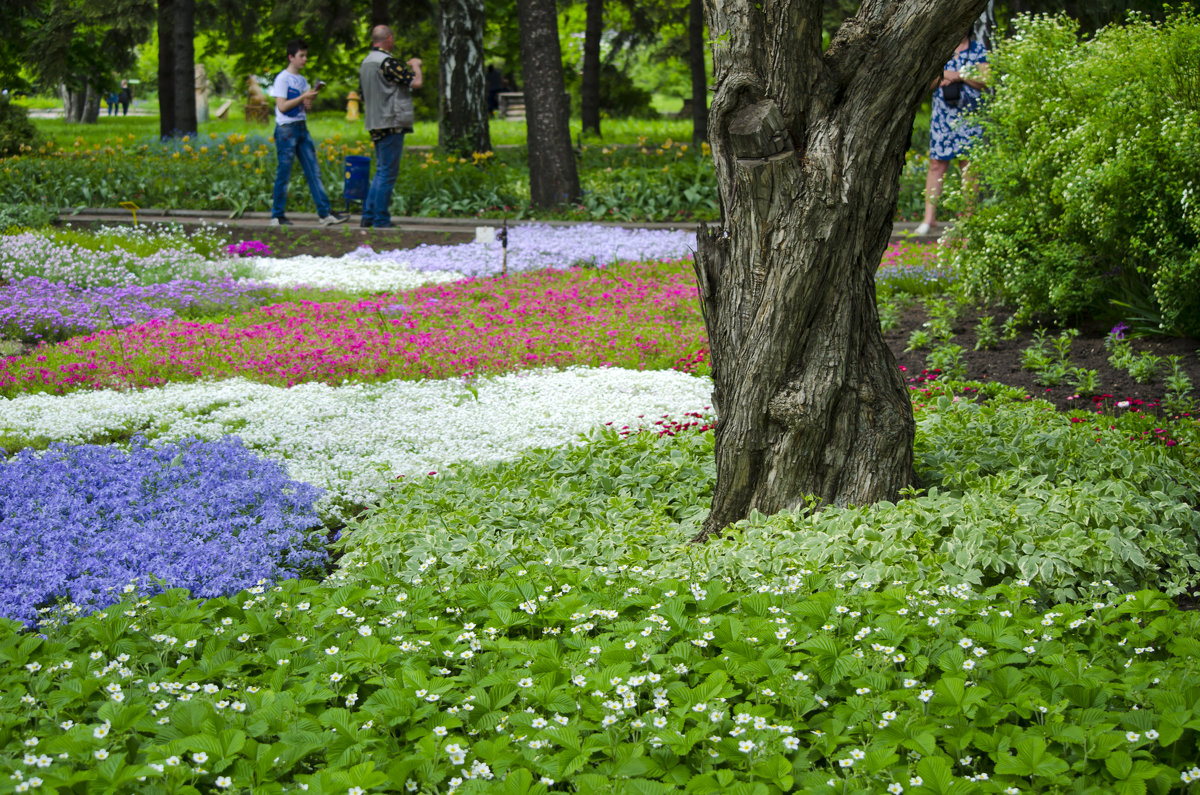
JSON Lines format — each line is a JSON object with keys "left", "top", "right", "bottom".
{"left": 241, "top": 250, "right": 464, "bottom": 292}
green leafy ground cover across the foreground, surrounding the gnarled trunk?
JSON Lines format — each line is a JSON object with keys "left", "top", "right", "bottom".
{"left": 7, "top": 388, "right": 1200, "bottom": 793}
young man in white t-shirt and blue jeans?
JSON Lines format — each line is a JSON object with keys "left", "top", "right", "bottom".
{"left": 270, "top": 38, "right": 347, "bottom": 226}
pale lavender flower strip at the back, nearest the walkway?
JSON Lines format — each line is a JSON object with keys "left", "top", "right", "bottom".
{"left": 355, "top": 223, "right": 696, "bottom": 277}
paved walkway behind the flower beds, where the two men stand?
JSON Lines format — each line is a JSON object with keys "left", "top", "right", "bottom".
{"left": 59, "top": 207, "right": 946, "bottom": 243}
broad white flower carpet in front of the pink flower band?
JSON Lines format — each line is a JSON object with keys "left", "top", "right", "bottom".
{"left": 0, "top": 367, "right": 713, "bottom": 515}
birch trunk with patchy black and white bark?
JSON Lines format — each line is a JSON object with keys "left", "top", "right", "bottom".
{"left": 438, "top": 0, "right": 492, "bottom": 156}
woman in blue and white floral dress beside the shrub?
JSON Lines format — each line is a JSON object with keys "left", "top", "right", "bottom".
{"left": 917, "top": 37, "right": 988, "bottom": 234}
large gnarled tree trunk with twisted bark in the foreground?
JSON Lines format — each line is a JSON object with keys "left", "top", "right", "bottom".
{"left": 696, "top": 0, "right": 986, "bottom": 538}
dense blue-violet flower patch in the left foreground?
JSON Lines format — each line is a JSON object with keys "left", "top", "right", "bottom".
{"left": 0, "top": 437, "right": 325, "bottom": 626}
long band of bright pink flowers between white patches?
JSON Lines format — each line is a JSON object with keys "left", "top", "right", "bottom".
{"left": 0, "top": 263, "right": 704, "bottom": 396}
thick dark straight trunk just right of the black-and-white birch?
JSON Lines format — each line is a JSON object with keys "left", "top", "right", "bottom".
{"left": 517, "top": 0, "right": 580, "bottom": 208}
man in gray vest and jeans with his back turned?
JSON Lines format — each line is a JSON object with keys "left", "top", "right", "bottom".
{"left": 359, "top": 25, "right": 421, "bottom": 229}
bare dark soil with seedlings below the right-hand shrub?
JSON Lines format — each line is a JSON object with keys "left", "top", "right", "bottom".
{"left": 883, "top": 303, "right": 1200, "bottom": 413}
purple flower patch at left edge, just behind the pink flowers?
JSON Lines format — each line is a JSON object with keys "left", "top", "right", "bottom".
{"left": 0, "top": 276, "right": 277, "bottom": 342}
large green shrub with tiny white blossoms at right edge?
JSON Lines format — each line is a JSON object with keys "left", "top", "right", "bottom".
{"left": 947, "top": 11, "right": 1200, "bottom": 335}
